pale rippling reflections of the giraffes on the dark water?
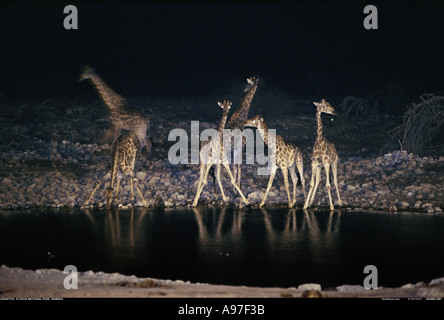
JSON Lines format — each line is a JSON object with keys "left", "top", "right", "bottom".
{"left": 83, "top": 207, "right": 341, "bottom": 260}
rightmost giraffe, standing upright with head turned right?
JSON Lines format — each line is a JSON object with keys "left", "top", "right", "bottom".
{"left": 304, "top": 99, "right": 342, "bottom": 211}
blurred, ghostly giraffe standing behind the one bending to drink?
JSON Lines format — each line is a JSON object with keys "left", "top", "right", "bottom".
{"left": 79, "top": 66, "right": 151, "bottom": 151}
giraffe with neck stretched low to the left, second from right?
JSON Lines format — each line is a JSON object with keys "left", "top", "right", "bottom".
{"left": 245, "top": 115, "right": 305, "bottom": 208}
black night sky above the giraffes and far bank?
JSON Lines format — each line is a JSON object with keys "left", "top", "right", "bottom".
{"left": 0, "top": 1, "right": 444, "bottom": 98}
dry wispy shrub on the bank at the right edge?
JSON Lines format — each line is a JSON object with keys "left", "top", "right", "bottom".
{"left": 390, "top": 94, "right": 444, "bottom": 154}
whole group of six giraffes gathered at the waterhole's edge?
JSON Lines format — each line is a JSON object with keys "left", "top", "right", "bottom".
{"left": 79, "top": 67, "right": 342, "bottom": 210}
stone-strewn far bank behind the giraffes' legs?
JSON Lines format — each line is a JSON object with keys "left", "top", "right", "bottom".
{"left": 0, "top": 140, "right": 444, "bottom": 213}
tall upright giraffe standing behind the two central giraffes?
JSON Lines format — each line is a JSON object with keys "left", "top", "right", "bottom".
{"left": 226, "top": 77, "right": 259, "bottom": 187}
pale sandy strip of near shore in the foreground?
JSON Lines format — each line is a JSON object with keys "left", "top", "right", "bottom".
{"left": 0, "top": 265, "right": 444, "bottom": 300}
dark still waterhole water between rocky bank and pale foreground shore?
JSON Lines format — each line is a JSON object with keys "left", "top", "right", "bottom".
{"left": 0, "top": 208, "right": 444, "bottom": 288}
